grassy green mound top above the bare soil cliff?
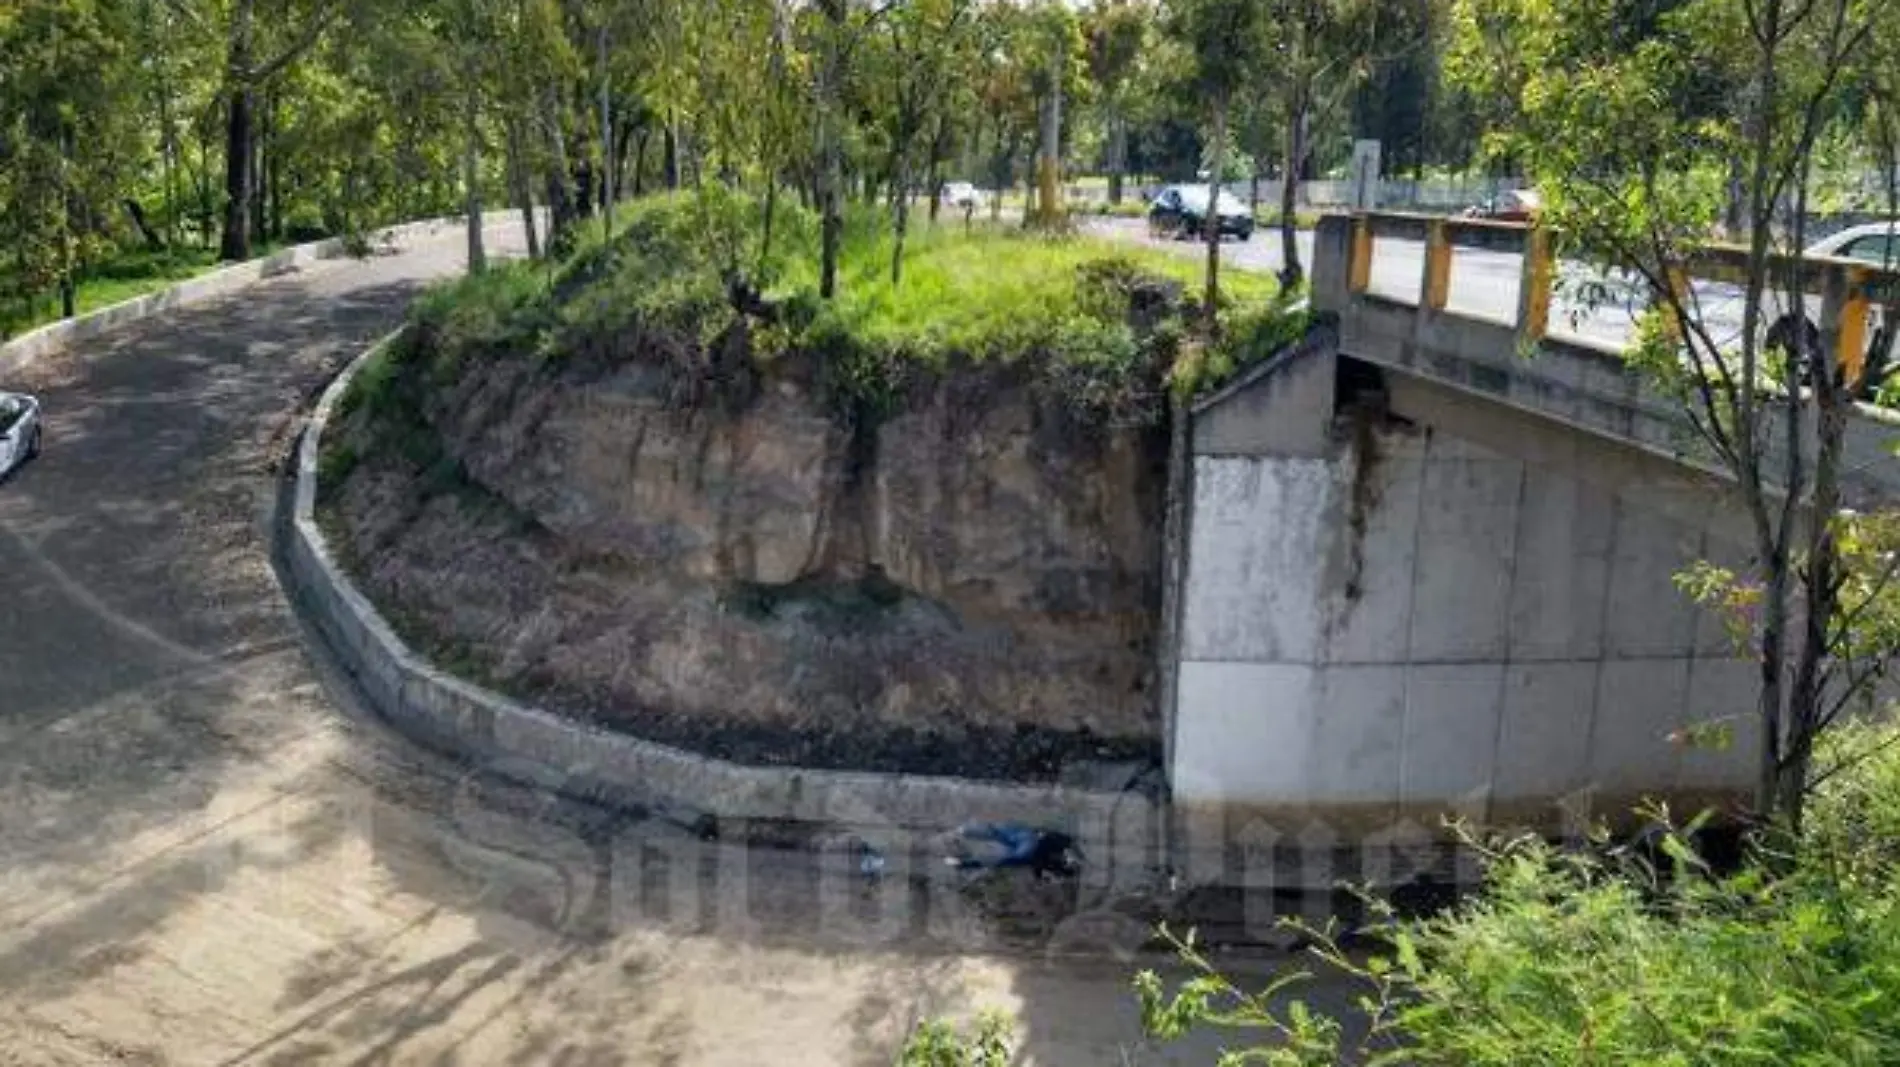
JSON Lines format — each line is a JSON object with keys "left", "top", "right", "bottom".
{"left": 365, "top": 188, "right": 1307, "bottom": 416}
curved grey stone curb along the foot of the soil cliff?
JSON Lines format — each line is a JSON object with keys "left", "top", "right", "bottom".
{"left": 281, "top": 334, "right": 1163, "bottom": 858}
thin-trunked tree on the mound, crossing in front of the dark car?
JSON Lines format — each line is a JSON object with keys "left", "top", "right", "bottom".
{"left": 1167, "top": 0, "right": 1267, "bottom": 338}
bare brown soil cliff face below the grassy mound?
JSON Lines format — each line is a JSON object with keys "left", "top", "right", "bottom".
{"left": 325, "top": 254, "right": 1167, "bottom": 778}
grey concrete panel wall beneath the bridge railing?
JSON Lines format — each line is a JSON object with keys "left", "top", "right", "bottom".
{"left": 1170, "top": 337, "right": 1758, "bottom": 833}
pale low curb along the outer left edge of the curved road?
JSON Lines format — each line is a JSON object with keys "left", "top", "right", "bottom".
{"left": 0, "top": 216, "right": 462, "bottom": 374}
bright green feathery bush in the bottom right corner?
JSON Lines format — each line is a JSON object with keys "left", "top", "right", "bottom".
{"left": 1136, "top": 723, "right": 1900, "bottom": 1067}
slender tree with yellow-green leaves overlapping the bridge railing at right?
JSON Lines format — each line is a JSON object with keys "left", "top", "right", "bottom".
{"left": 1450, "top": 0, "right": 1896, "bottom": 828}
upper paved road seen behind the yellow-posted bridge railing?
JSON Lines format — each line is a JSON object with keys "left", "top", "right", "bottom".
{"left": 1089, "top": 218, "right": 1656, "bottom": 346}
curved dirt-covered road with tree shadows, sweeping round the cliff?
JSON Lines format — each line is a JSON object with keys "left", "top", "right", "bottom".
{"left": 0, "top": 228, "right": 1261, "bottom": 1067}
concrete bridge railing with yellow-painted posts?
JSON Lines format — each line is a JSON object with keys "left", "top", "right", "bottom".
{"left": 1337, "top": 211, "right": 1900, "bottom": 382}
